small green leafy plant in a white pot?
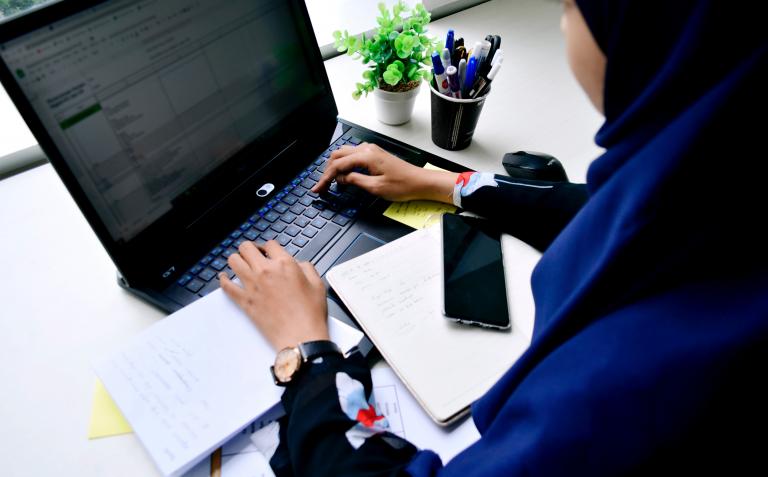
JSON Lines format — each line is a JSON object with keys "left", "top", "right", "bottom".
{"left": 333, "top": 1, "right": 437, "bottom": 125}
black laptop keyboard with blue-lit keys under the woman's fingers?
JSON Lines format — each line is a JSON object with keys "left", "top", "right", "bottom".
{"left": 174, "top": 134, "right": 373, "bottom": 300}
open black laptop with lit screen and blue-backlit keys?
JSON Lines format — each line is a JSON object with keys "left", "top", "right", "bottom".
{"left": 0, "top": 0, "right": 461, "bottom": 319}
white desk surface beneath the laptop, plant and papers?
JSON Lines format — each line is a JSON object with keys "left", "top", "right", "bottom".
{"left": 0, "top": 0, "right": 601, "bottom": 476}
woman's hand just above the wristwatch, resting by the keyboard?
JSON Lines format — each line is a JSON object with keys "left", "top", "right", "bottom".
{"left": 219, "top": 240, "right": 329, "bottom": 350}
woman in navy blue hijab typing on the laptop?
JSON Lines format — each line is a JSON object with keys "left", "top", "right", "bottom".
{"left": 222, "top": 0, "right": 768, "bottom": 476}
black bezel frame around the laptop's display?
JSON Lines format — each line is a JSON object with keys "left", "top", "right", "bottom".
{"left": 0, "top": 0, "right": 338, "bottom": 289}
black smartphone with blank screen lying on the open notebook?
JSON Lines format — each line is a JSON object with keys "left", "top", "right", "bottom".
{"left": 442, "top": 214, "right": 512, "bottom": 330}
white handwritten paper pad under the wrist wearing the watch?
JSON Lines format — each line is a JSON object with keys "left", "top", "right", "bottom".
{"left": 94, "top": 290, "right": 362, "bottom": 475}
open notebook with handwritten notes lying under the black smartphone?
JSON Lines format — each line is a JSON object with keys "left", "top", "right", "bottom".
{"left": 326, "top": 225, "right": 540, "bottom": 425}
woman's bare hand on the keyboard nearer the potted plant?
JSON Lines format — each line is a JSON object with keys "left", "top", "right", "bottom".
{"left": 312, "top": 139, "right": 458, "bottom": 204}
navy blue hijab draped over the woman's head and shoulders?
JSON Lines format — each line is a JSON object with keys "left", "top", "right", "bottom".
{"left": 413, "top": 0, "right": 768, "bottom": 475}
